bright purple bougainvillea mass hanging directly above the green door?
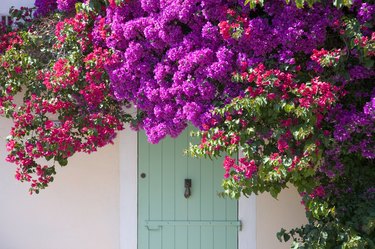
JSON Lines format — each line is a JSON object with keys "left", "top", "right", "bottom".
{"left": 106, "top": 0, "right": 238, "bottom": 143}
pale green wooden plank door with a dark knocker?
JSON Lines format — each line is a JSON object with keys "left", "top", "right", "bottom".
{"left": 138, "top": 127, "right": 239, "bottom": 249}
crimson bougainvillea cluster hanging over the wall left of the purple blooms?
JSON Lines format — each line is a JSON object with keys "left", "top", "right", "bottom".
{"left": 0, "top": 3, "right": 130, "bottom": 193}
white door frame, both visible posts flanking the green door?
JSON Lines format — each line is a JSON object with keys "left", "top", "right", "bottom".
{"left": 119, "top": 126, "right": 257, "bottom": 249}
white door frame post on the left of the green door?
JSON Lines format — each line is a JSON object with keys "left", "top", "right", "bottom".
{"left": 119, "top": 126, "right": 138, "bottom": 249}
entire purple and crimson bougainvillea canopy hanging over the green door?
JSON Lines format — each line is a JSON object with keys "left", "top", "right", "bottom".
{"left": 0, "top": 0, "right": 375, "bottom": 248}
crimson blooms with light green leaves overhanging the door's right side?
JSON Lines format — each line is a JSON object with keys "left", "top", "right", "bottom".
{"left": 191, "top": 64, "right": 341, "bottom": 198}
